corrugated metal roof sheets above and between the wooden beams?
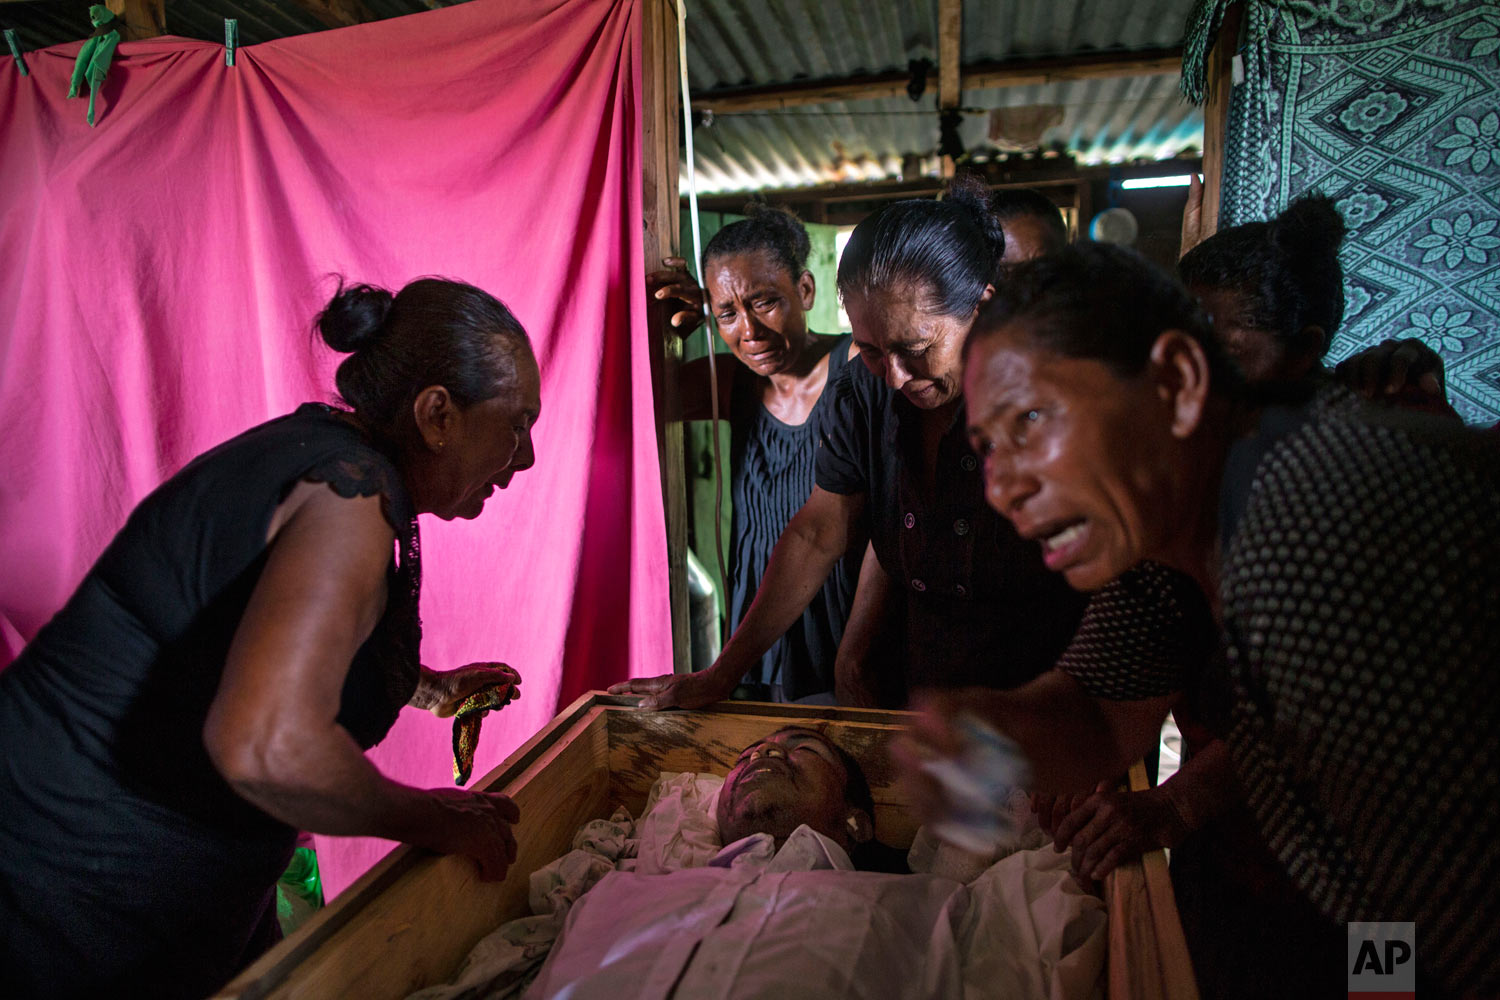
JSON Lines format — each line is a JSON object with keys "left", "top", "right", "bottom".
{"left": 0, "top": 0, "right": 1203, "bottom": 193}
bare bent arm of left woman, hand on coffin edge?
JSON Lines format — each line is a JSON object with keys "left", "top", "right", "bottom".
{"left": 204, "top": 484, "right": 519, "bottom": 877}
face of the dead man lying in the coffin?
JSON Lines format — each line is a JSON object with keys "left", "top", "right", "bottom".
{"left": 717, "top": 729, "right": 852, "bottom": 847}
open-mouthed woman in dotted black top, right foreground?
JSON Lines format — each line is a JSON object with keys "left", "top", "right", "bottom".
{"left": 936, "top": 246, "right": 1500, "bottom": 996}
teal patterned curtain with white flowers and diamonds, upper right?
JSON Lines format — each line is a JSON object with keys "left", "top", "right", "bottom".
{"left": 1184, "top": 0, "right": 1500, "bottom": 423}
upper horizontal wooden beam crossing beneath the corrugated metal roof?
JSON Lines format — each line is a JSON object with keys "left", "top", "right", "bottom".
{"left": 693, "top": 48, "right": 1182, "bottom": 114}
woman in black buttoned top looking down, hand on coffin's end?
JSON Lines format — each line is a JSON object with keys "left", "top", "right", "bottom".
{"left": 620, "top": 178, "right": 1085, "bottom": 708}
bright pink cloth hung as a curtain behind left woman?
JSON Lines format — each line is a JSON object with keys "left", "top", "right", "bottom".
{"left": 0, "top": 0, "right": 671, "bottom": 892}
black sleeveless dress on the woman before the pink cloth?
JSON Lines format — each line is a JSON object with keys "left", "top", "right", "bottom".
{"left": 0, "top": 403, "right": 420, "bottom": 997}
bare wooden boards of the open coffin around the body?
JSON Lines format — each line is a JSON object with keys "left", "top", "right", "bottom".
{"left": 218, "top": 693, "right": 1197, "bottom": 1000}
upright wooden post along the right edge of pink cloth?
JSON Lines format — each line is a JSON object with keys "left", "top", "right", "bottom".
{"left": 642, "top": 0, "right": 692, "bottom": 673}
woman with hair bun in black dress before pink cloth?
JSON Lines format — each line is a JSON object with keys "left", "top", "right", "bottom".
{"left": 0, "top": 277, "right": 540, "bottom": 997}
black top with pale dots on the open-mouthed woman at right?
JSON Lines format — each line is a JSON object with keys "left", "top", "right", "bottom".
{"left": 1062, "top": 390, "right": 1500, "bottom": 996}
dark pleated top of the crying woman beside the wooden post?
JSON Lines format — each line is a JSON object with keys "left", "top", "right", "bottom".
{"left": 729, "top": 334, "right": 864, "bottom": 700}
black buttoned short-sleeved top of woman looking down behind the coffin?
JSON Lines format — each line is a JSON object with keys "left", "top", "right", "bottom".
{"left": 818, "top": 364, "right": 1085, "bottom": 688}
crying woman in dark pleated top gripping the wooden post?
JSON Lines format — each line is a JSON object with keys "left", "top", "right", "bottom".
{"left": 617, "top": 204, "right": 864, "bottom": 702}
